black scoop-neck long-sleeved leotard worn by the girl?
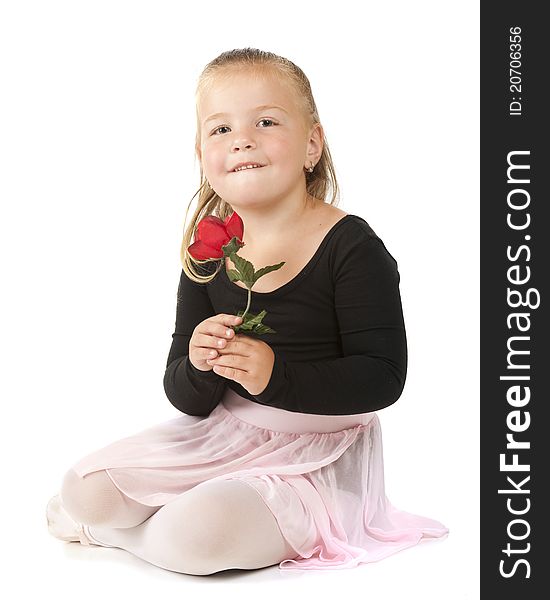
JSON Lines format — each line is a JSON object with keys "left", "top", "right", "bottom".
{"left": 164, "top": 214, "right": 407, "bottom": 416}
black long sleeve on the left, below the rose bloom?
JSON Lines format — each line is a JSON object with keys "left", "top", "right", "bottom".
{"left": 163, "top": 269, "right": 227, "bottom": 416}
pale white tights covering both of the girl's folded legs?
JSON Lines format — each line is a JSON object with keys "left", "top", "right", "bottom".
{"left": 60, "top": 469, "right": 297, "bottom": 575}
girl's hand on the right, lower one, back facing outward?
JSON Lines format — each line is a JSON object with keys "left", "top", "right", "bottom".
{"left": 206, "top": 333, "right": 275, "bottom": 396}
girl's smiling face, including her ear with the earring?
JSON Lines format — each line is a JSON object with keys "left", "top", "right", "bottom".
{"left": 197, "top": 72, "right": 322, "bottom": 210}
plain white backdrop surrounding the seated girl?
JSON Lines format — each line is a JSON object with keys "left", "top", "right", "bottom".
{"left": 0, "top": 0, "right": 479, "bottom": 600}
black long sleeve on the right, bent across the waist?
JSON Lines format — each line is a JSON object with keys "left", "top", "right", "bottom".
{"left": 254, "top": 237, "right": 407, "bottom": 415}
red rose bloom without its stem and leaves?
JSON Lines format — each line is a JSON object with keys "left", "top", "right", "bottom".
{"left": 188, "top": 211, "right": 244, "bottom": 260}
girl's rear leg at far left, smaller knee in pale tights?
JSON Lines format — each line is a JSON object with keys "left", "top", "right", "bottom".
{"left": 59, "top": 469, "right": 160, "bottom": 527}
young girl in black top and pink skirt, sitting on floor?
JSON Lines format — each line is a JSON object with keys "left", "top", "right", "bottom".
{"left": 47, "top": 48, "right": 447, "bottom": 575}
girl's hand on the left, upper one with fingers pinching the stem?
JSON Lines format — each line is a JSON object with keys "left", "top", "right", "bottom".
{"left": 189, "top": 313, "right": 242, "bottom": 371}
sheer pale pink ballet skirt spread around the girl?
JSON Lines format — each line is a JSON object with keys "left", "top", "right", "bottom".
{"left": 72, "top": 388, "right": 448, "bottom": 570}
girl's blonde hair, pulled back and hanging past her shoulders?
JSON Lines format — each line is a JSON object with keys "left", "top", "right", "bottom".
{"left": 180, "top": 48, "right": 340, "bottom": 283}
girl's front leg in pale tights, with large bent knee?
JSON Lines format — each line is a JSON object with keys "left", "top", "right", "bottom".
{"left": 88, "top": 479, "right": 297, "bottom": 575}
